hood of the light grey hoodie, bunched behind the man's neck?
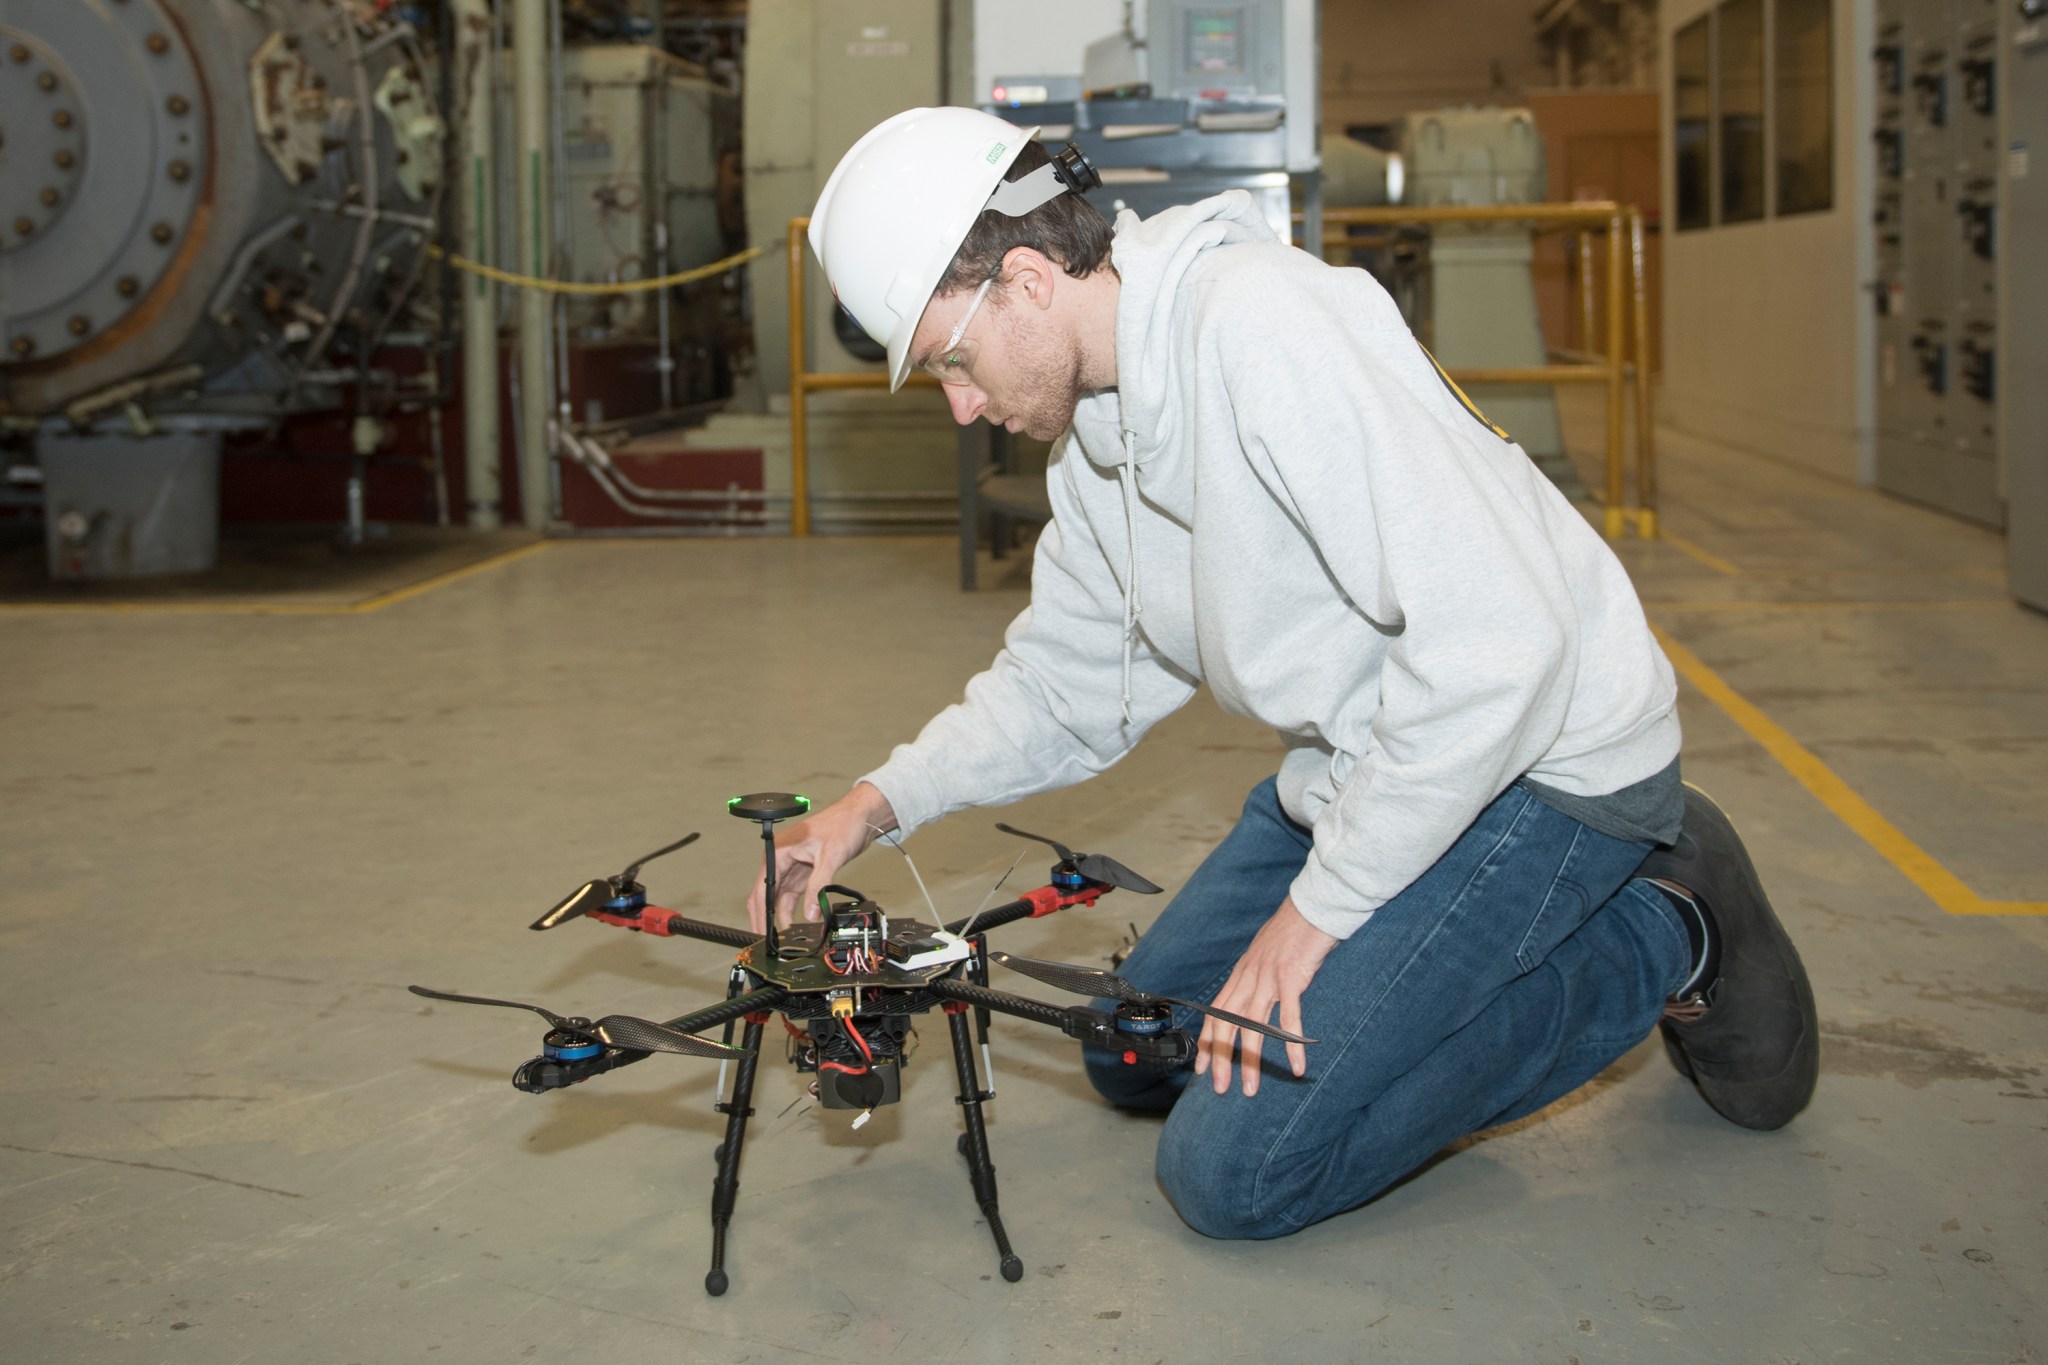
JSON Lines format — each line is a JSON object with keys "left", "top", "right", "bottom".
{"left": 1075, "top": 190, "right": 1278, "bottom": 469}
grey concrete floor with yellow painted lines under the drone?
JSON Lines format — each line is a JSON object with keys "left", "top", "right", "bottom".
{"left": 0, "top": 409, "right": 2048, "bottom": 1365}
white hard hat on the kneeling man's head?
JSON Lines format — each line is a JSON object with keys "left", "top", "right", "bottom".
{"left": 809, "top": 108, "right": 1067, "bottom": 389}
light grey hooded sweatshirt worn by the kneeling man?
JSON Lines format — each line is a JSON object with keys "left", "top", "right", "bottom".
{"left": 866, "top": 192, "right": 1679, "bottom": 937}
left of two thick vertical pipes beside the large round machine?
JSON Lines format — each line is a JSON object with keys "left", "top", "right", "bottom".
{"left": 453, "top": 0, "right": 504, "bottom": 530}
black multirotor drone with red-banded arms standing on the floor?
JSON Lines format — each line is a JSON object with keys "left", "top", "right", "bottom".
{"left": 412, "top": 792, "right": 1313, "bottom": 1295}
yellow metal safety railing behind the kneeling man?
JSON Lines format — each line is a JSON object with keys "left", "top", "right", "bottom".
{"left": 788, "top": 201, "right": 1657, "bottom": 540}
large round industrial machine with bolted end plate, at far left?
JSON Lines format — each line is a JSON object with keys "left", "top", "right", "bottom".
{"left": 0, "top": 0, "right": 444, "bottom": 577}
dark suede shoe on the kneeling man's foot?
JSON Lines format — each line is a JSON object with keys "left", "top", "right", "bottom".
{"left": 1636, "top": 784, "right": 1821, "bottom": 1128}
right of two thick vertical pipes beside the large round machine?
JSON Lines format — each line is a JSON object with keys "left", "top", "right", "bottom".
{"left": 512, "top": 0, "right": 555, "bottom": 528}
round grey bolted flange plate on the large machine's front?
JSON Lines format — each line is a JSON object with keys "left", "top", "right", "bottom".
{"left": 0, "top": 0, "right": 213, "bottom": 366}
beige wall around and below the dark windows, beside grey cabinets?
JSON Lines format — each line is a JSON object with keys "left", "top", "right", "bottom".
{"left": 1661, "top": 0, "right": 1874, "bottom": 483}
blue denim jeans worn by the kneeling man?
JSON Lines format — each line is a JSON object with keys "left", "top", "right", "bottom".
{"left": 1083, "top": 780, "right": 1692, "bottom": 1238}
